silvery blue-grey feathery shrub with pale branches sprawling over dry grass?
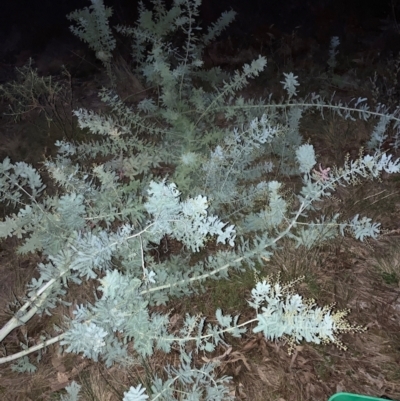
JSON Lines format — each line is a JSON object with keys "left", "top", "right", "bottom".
{"left": 0, "top": 0, "right": 400, "bottom": 401}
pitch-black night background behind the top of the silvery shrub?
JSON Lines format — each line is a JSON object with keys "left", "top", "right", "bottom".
{"left": 0, "top": 0, "right": 400, "bottom": 79}
